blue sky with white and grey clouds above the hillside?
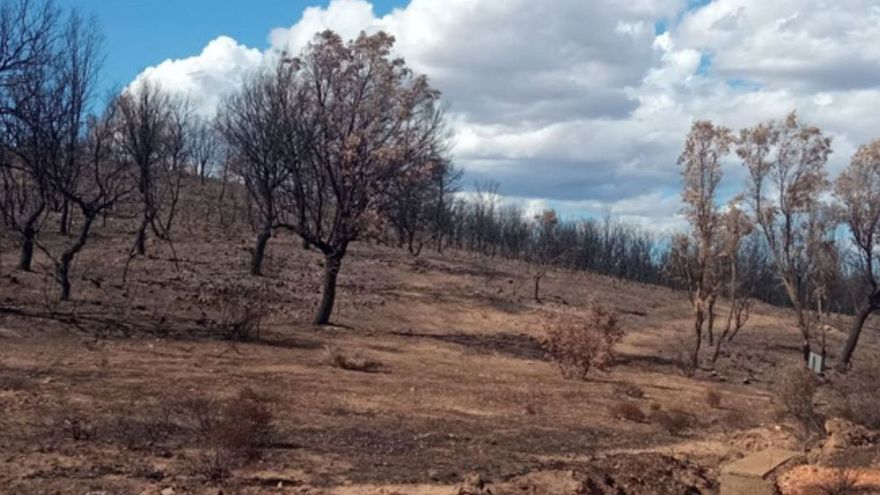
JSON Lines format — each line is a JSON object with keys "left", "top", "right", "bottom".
{"left": 61, "top": 0, "right": 880, "bottom": 232}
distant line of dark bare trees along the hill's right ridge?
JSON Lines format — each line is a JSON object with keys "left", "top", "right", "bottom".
{"left": 392, "top": 180, "right": 864, "bottom": 314}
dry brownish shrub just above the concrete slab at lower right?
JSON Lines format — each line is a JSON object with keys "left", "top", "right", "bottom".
{"left": 774, "top": 364, "right": 823, "bottom": 432}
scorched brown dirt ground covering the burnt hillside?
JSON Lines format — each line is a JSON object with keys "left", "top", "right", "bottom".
{"left": 0, "top": 192, "right": 880, "bottom": 495}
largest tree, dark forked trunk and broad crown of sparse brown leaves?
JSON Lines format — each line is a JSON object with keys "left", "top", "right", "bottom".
{"left": 280, "top": 31, "right": 445, "bottom": 325}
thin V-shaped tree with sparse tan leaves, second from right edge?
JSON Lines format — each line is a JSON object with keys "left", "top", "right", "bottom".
{"left": 737, "top": 112, "right": 831, "bottom": 361}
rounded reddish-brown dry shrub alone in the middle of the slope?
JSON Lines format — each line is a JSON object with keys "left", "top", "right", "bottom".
{"left": 544, "top": 304, "right": 624, "bottom": 379}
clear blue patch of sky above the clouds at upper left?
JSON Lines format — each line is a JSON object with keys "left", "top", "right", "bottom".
{"left": 56, "top": 0, "right": 406, "bottom": 95}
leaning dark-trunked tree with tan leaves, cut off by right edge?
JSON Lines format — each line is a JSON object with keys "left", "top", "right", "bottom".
{"left": 834, "top": 139, "right": 880, "bottom": 369}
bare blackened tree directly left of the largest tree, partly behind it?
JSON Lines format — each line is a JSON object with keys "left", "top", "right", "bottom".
{"left": 217, "top": 59, "right": 296, "bottom": 275}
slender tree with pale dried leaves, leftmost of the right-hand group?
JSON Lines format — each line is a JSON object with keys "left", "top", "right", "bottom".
{"left": 676, "top": 121, "right": 733, "bottom": 369}
